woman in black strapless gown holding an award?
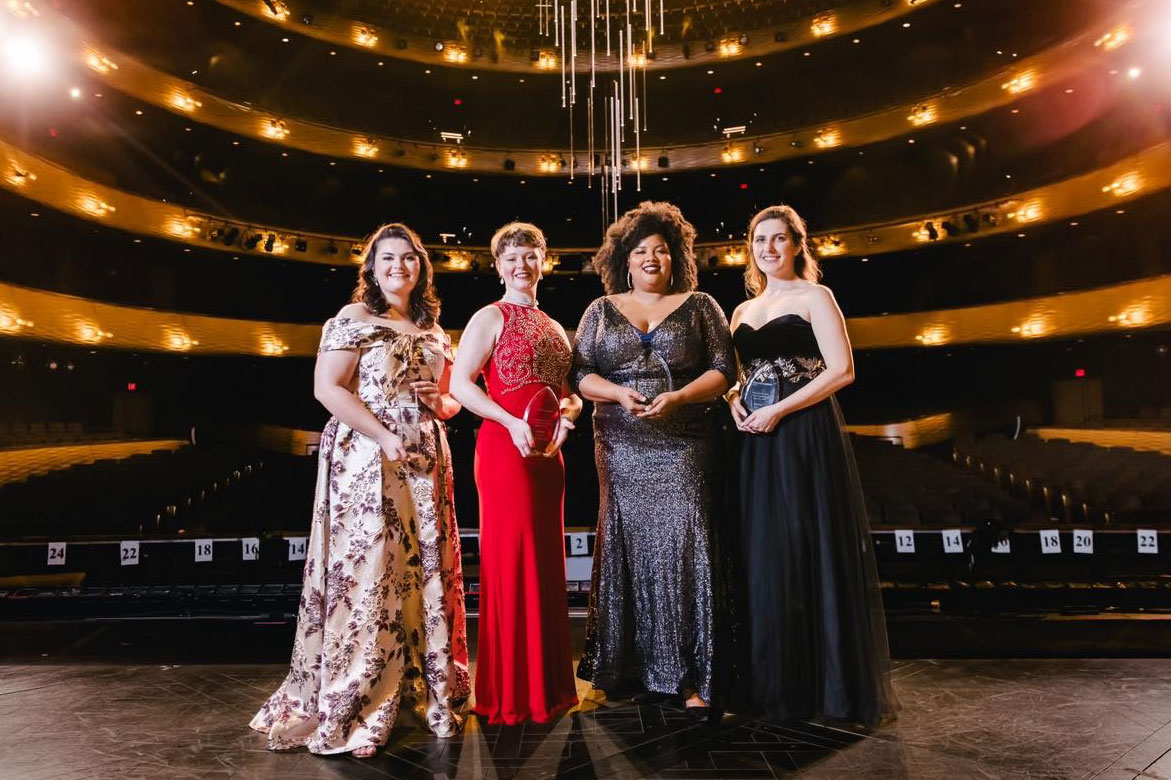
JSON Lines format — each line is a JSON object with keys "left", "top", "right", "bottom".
{"left": 728, "top": 206, "right": 895, "bottom": 726}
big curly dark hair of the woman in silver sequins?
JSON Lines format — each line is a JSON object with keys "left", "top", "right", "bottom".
{"left": 594, "top": 200, "right": 699, "bottom": 295}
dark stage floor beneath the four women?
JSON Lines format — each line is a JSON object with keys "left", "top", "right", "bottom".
{"left": 0, "top": 625, "right": 1171, "bottom": 780}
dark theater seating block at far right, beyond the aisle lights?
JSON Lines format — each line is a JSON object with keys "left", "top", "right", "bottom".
{"left": 952, "top": 435, "right": 1171, "bottom": 528}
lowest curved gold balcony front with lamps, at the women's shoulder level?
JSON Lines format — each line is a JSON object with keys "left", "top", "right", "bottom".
{"left": 0, "top": 275, "right": 1171, "bottom": 357}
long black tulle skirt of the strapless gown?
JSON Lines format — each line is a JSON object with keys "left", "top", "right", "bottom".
{"left": 740, "top": 398, "right": 896, "bottom": 726}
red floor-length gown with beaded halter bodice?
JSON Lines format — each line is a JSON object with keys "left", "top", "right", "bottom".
{"left": 474, "top": 301, "right": 577, "bottom": 724}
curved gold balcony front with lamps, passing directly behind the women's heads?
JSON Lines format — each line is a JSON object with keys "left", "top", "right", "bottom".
{"left": 0, "top": 133, "right": 1171, "bottom": 264}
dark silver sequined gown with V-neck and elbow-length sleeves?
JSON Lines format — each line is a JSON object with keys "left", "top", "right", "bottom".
{"left": 573, "top": 293, "right": 735, "bottom": 700}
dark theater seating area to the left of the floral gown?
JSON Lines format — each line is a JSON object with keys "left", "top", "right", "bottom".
{"left": 0, "top": 446, "right": 313, "bottom": 540}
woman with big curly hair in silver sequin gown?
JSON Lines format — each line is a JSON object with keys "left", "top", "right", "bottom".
{"left": 573, "top": 203, "right": 734, "bottom": 714}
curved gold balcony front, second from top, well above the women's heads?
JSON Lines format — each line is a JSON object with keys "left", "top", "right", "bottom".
{"left": 57, "top": 7, "right": 1138, "bottom": 176}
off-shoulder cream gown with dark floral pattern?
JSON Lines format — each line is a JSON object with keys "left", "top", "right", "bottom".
{"left": 251, "top": 316, "right": 470, "bottom": 753}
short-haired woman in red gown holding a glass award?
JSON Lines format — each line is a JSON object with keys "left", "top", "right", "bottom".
{"left": 451, "top": 223, "right": 581, "bottom": 724}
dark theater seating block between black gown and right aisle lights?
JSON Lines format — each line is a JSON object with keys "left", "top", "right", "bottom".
{"left": 852, "top": 437, "right": 1039, "bottom": 529}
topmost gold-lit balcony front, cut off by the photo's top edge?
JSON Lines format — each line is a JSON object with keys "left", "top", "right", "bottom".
{"left": 217, "top": 0, "right": 941, "bottom": 73}
